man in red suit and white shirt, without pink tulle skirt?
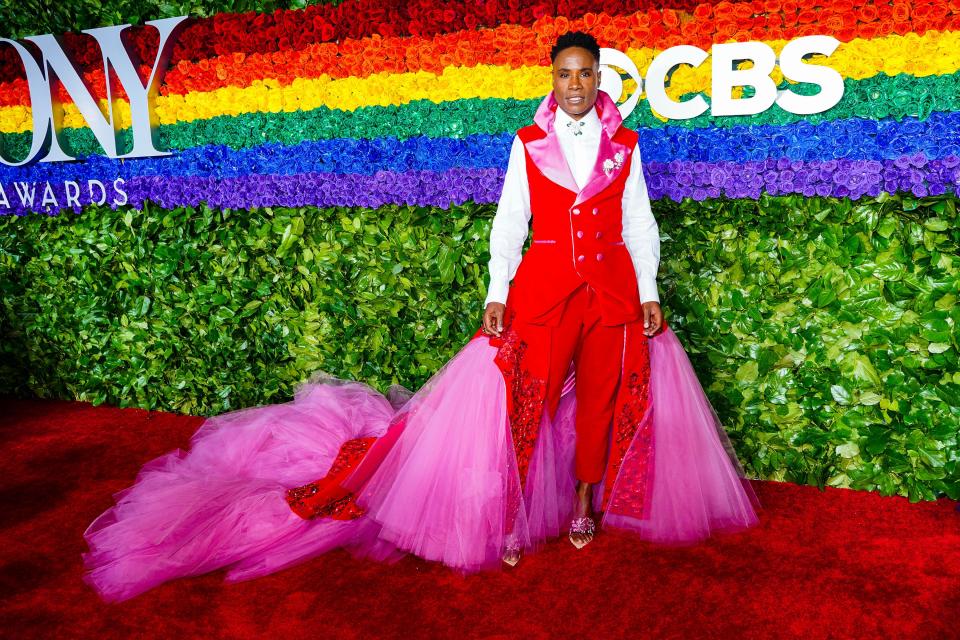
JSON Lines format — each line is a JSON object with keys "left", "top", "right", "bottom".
{"left": 483, "top": 32, "right": 663, "bottom": 552}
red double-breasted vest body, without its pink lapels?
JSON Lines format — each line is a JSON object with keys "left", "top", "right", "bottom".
{"left": 507, "top": 124, "right": 643, "bottom": 325}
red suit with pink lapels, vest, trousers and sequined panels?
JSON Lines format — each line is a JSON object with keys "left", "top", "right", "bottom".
{"left": 497, "top": 87, "right": 649, "bottom": 502}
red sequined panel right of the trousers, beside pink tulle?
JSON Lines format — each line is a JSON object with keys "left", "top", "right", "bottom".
{"left": 604, "top": 331, "right": 653, "bottom": 518}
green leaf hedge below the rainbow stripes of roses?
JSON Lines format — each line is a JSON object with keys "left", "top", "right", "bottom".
{"left": 0, "top": 191, "right": 960, "bottom": 500}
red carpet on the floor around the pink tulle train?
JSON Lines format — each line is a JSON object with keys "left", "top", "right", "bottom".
{"left": 0, "top": 400, "right": 960, "bottom": 640}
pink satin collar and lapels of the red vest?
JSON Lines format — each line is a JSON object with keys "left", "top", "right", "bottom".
{"left": 526, "top": 91, "right": 632, "bottom": 204}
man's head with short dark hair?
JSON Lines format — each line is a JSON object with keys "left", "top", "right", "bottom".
{"left": 550, "top": 31, "right": 600, "bottom": 120}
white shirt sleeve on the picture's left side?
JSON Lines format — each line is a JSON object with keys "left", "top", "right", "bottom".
{"left": 483, "top": 136, "right": 530, "bottom": 307}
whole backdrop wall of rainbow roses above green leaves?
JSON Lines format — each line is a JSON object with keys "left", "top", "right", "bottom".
{"left": 0, "top": 0, "right": 960, "bottom": 500}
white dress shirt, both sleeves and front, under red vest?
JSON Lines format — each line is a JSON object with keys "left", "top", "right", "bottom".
{"left": 484, "top": 107, "right": 660, "bottom": 306}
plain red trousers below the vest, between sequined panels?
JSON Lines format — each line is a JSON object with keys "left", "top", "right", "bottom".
{"left": 517, "top": 284, "right": 624, "bottom": 483}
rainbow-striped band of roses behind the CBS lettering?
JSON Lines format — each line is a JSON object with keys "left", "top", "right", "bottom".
{"left": 0, "top": 0, "right": 960, "bottom": 213}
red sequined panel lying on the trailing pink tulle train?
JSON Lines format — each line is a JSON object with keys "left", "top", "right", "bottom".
{"left": 287, "top": 438, "right": 377, "bottom": 520}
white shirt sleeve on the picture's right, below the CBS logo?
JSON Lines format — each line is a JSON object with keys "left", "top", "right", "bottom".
{"left": 623, "top": 146, "right": 660, "bottom": 302}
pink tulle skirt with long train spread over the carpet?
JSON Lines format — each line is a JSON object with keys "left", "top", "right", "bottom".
{"left": 84, "top": 330, "right": 759, "bottom": 601}
